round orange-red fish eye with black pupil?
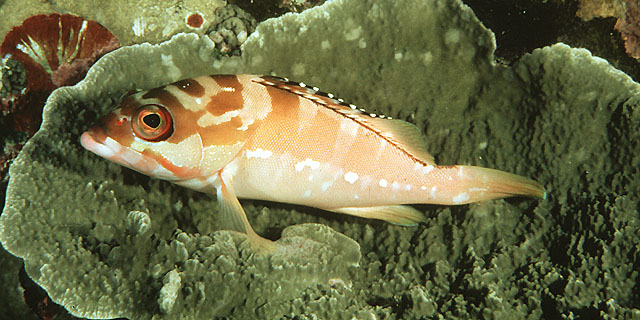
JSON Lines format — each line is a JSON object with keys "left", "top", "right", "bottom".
{"left": 132, "top": 104, "right": 173, "bottom": 142}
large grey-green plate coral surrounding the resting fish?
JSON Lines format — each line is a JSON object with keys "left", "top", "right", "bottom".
{"left": 0, "top": 0, "right": 640, "bottom": 319}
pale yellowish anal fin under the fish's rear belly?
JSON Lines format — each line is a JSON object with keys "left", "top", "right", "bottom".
{"left": 325, "top": 205, "right": 425, "bottom": 226}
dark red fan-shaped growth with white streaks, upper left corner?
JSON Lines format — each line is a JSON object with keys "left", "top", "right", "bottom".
{"left": 0, "top": 13, "right": 120, "bottom": 133}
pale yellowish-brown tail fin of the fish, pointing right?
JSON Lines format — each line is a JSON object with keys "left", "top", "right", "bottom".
{"left": 439, "top": 166, "right": 547, "bottom": 204}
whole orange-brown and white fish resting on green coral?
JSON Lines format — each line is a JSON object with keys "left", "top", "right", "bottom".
{"left": 80, "top": 75, "right": 546, "bottom": 248}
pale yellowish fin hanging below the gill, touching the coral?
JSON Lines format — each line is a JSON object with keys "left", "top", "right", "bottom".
{"left": 217, "top": 173, "right": 275, "bottom": 251}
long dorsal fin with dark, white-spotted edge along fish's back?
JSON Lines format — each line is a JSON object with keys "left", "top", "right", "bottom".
{"left": 255, "top": 76, "right": 435, "bottom": 166}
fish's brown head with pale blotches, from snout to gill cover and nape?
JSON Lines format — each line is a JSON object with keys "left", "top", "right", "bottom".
{"left": 81, "top": 75, "right": 269, "bottom": 182}
